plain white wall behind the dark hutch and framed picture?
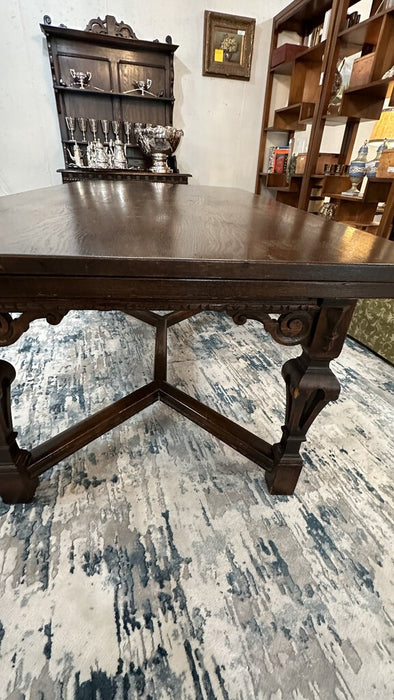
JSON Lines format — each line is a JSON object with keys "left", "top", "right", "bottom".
{"left": 0, "top": 0, "right": 288, "bottom": 194}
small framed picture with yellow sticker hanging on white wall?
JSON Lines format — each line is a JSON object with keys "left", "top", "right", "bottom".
{"left": 202, "top": 10, "right": 256, "bottom": 80}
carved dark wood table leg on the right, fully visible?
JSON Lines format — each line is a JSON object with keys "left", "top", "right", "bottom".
{"left": 266, "top": 300, "right": 355, "bottom": 495}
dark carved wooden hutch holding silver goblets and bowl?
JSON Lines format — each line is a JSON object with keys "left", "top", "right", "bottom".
{"left": 40, "top": 15, "right": 190, "bottom": 184}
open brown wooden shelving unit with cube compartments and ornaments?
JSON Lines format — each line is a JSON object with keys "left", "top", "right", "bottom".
{"left": 256, "top": 0, "right": 394, "bottom": 238}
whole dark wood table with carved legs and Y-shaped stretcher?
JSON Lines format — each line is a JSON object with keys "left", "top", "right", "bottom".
{"left": 0, "top": 181, "right": 394, "bottom": 503}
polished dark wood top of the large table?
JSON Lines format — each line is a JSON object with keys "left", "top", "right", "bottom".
{"left": 0, "top": 181, "right": 394, "bottom": 297}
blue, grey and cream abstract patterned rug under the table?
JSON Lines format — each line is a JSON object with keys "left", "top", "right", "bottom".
{"left": 0, "top": 312, "right": 394, "bottom": 700}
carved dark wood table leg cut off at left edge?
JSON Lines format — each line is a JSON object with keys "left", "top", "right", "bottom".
{"left": 0, "top": 360, "right": 38, "bottom": 503}
